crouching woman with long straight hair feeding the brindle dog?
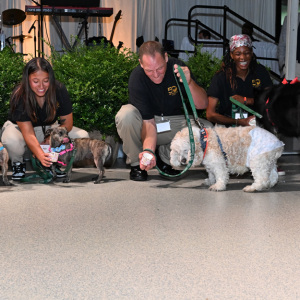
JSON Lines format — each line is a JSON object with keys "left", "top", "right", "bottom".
{"left": 2, "top": 57, "right": 89, "bottom": 180}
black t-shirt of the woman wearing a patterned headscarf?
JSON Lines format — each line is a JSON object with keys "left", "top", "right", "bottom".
{"left": 207, "top": 64, "right": 272, "bottom": 118}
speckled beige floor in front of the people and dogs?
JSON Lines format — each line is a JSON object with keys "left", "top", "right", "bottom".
{"left": 0, "top": 155, "right": 300, "bottom": 300}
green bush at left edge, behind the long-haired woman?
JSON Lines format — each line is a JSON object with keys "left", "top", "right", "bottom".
{"left": 0, "top": 47, "right": 25, "bottom": 126}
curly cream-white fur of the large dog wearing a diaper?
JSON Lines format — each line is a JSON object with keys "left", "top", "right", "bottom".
{"left": 170, "top": 126, "right": 284, "bottom": 192}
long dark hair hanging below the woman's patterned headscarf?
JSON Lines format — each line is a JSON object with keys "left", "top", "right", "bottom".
{"left": 218, "top": 50, "right": 257, "bottom": 90}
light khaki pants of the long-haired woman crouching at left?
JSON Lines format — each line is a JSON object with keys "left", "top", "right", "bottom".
{"left": 1, "top": 121, "right": 89, "bottom": 163}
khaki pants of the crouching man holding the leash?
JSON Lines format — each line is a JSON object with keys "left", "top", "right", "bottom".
{"left": 115, "top": 104, "right": 212, "bottom": 166}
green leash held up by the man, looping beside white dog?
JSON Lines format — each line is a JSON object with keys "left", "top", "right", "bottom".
{"left": 143, "top": 66, "right": 203, "bottom": 177}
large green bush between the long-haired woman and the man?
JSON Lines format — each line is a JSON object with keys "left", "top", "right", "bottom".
{"left": 49, "top": 42, "right": 138, "bottom": 135}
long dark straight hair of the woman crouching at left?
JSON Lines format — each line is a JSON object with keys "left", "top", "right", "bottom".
{"left": 10, "top": 57, "right": 56, "bottom": 122}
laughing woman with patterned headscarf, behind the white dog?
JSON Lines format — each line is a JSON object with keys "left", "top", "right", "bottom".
{"left": 206, "top": 34, "right": 272, "bottom": 126}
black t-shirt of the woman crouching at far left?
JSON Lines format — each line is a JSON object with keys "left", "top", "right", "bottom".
{"left": 9, "top": 82, "right": 72, "bottom": 127}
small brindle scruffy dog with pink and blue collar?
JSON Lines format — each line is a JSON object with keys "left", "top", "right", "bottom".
{"left": 45, "top": 127, "right": 112, "bottom": 183}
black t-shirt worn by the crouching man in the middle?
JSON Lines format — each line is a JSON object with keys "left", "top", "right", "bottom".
{"left": 129, "top": 57, "right": 195, "bottom": 120}
